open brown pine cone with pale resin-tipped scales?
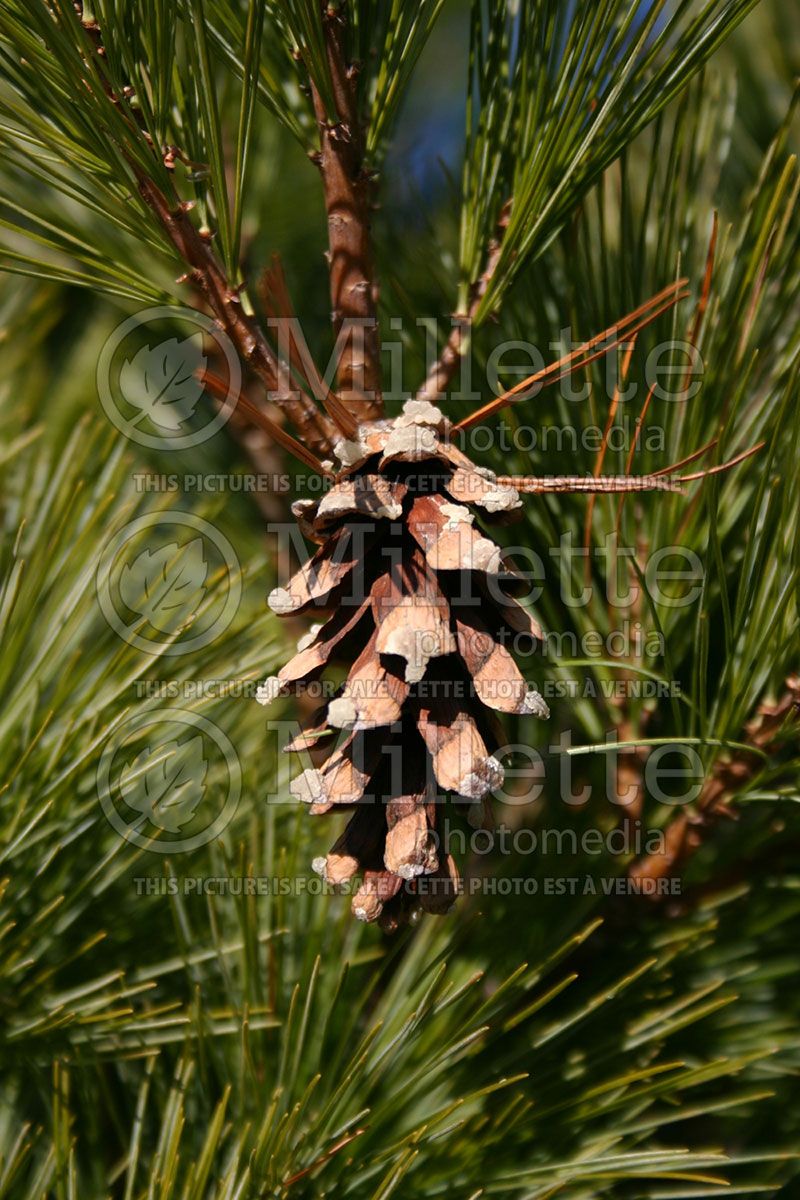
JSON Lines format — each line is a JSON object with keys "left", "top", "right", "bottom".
{"left": 258, "top": 401, "right": 548, "bottom": 929}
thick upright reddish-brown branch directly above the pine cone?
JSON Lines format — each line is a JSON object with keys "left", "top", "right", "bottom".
{"left": 312, "top": 8, "right": 384, "bottom": 421}
